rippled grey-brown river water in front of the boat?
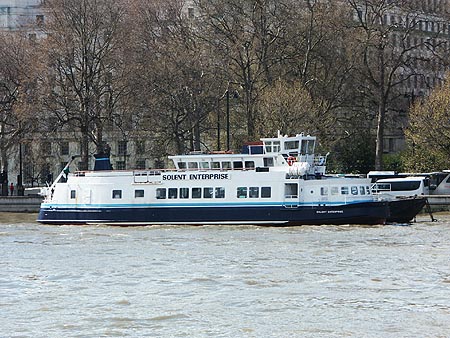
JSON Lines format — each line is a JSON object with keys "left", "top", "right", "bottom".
{"left": 0, "top": 214, "right": 450, "bottom": 338}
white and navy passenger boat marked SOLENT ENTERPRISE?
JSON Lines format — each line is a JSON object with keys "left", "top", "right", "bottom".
{"left": 38, "top": 133, "right": 388, "bottom": 226}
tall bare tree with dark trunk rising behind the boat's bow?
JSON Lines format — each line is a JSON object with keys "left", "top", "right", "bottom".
{"left": 347, "top": 0, "right": 432, "bottom": 170}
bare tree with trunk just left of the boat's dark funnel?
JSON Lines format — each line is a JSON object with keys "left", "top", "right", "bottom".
{"left": 38, "top": 0, "right": 128, "bottom": 169}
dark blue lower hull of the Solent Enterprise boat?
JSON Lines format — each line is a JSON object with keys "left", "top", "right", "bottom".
{"left": 38, "top": 202, "right": 389, "bottom": 226}
